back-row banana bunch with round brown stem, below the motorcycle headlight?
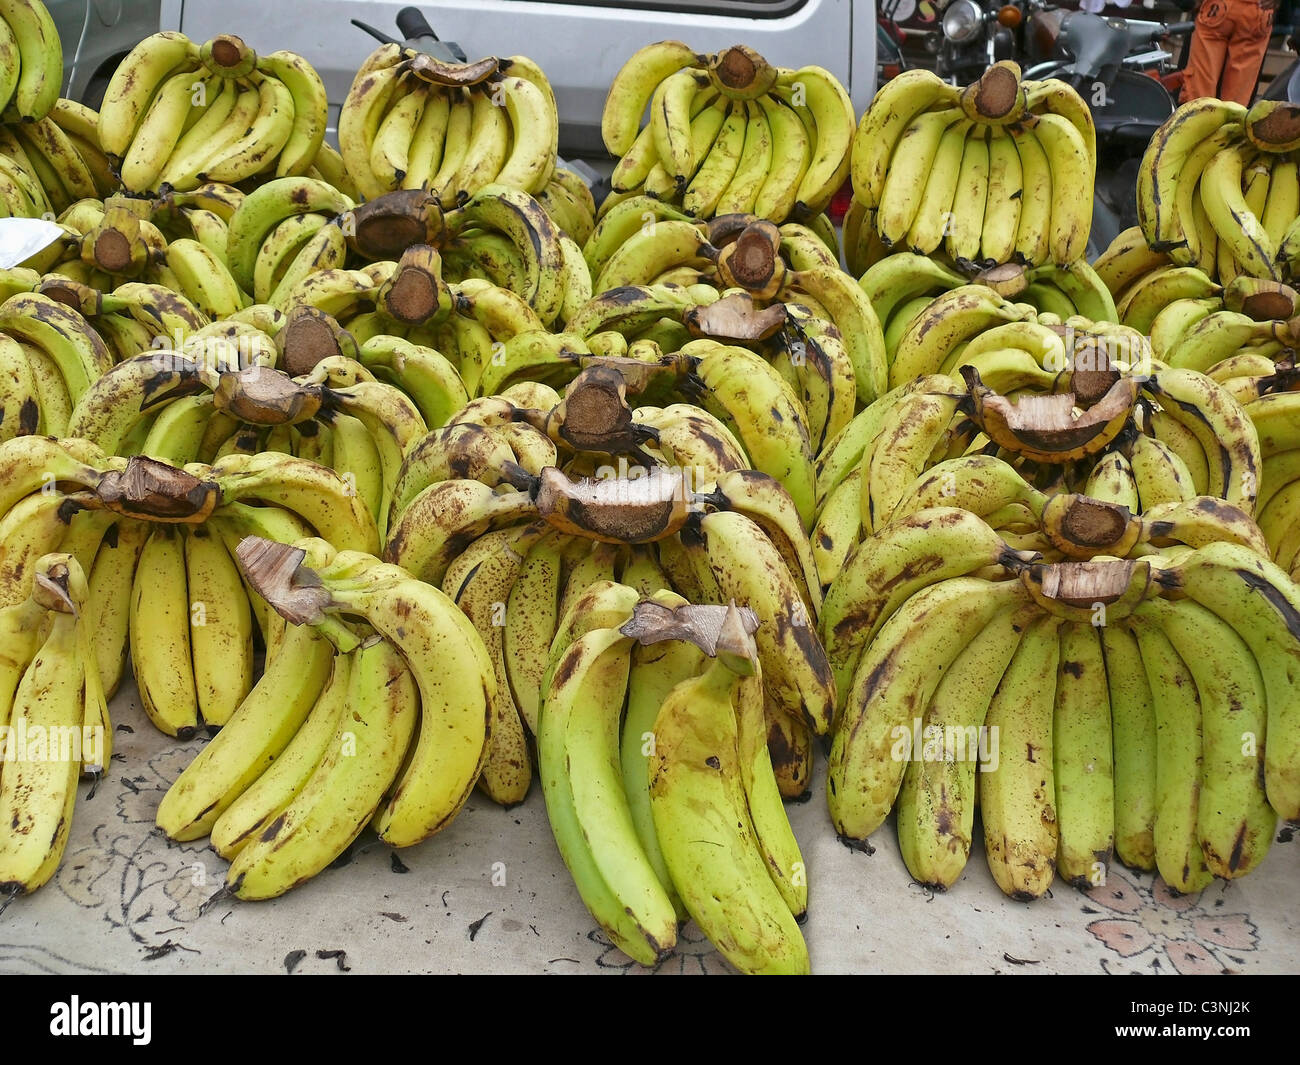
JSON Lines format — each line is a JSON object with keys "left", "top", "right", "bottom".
{"left": 845, "top": 60, "right": 1097, "bottom": 273}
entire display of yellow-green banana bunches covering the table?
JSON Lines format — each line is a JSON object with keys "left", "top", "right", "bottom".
{"left": 0, "top": 3, "right": 1300, "bottom": 973}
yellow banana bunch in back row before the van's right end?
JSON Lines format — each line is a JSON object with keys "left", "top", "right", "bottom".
{"left": 601, "top": 40, "right": 854, "bottom": 222}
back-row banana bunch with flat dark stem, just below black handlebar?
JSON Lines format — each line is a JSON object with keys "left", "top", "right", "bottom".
{"left": 338, "top": 44, "right": 560, "bottom": 207}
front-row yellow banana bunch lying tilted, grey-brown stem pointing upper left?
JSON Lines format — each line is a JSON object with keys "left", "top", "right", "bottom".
{"left": 150, "top": 534, "right": 495, "bottom": 899}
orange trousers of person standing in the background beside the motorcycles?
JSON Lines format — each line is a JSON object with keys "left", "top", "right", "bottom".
{"left": 1179, "top": 0, "right": 1273, "bottom": 107}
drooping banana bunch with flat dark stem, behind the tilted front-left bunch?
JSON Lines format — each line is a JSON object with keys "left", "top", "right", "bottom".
{"left": 0, "top": 429, "right": 380, "bottom": 737}
